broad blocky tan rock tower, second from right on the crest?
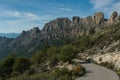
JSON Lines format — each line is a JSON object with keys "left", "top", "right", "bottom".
{"left": 93, "top": 12, "right": 104, "bottom": 25}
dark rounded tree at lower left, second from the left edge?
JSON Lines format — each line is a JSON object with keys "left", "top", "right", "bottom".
{"left": 13, "top": 58, "right": 31, "bottom": 73}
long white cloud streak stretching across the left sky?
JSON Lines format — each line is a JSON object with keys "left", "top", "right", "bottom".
{"left": 0, "top": 11, "right": 51, "bottom": 21}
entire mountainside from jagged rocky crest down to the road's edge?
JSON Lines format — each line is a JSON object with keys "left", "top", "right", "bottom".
{"left": 0, "top": 12, "right": 120, "bottom": 80}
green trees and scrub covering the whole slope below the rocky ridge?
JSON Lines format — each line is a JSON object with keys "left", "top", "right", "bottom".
{"left": 0, "top": 20, "right": 120, "bottom": 80}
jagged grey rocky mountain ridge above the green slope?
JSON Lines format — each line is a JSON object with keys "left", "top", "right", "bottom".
{"left": 0, "top": 12, "right": 120, "bottom": 56}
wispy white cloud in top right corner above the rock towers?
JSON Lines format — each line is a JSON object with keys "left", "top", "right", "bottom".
{"left": 90, "top": 0, "right": 120, "bottom": 15}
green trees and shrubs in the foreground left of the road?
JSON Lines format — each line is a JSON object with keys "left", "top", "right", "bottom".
{"left": 0, "top": 45, "right": 86, "bottom": 80}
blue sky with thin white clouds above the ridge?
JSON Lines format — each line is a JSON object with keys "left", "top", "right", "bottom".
{"left": 0, "top": 0, "right": 120, "bottom": 33}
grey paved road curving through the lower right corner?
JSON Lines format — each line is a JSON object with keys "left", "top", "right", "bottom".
{"left": 76, "top": 63, "right": 119, "bottom": 80}
